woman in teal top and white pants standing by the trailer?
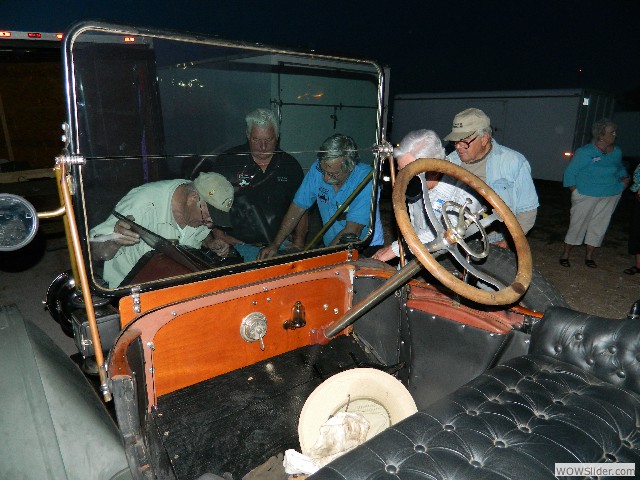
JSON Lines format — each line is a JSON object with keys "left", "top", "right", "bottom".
{"left": 560, "top": 118, "right": 629, "bottom": 268}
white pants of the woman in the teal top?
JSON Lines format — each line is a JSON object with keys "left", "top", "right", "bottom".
{"left": 564, "top": 189, "right": 620, "bottom": 247}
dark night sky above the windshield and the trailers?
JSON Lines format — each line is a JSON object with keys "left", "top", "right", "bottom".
{"left": 0, "top": 0, "right": 640, "bottom": 98}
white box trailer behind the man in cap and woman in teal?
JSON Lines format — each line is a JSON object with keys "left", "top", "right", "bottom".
{"left": 391, "top": 89, "right": 614, "bottom": 181}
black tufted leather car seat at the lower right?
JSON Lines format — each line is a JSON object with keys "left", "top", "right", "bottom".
{"left": 311, "top": 308, "right": 640, "bottom": 480}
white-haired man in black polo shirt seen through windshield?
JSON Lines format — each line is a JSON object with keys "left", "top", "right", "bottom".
{"left": 194, "top": 108, "right": 308, "bottom": 261}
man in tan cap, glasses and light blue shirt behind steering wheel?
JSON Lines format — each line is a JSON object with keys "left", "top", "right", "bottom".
{"left": 444, "top": 108, "right": 539, "bottom": 247}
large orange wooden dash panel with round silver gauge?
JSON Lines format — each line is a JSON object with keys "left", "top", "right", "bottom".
{"left": 115, "top": 264, "right": 355, "bottom": 407}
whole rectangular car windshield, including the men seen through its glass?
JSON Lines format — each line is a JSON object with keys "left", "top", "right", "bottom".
{"left": 65, "top": 24, "right": 383, "bottom": 289}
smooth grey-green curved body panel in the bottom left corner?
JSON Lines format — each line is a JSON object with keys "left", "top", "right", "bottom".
{"left": 0, "top": 306, "right": 132, "bottom": 479}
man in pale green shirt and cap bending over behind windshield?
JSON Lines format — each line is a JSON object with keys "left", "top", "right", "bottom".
{"left": 89, "top": 173, "right": 233, "bottom": 288}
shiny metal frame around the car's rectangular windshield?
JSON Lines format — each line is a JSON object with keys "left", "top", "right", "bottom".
{"left": 63, "top": 22, "right": 387, "bottom": 296}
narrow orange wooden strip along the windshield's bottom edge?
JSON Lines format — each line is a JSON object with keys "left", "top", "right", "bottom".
{"left": 120, "top": 251, "right": 350, "bottom": 327}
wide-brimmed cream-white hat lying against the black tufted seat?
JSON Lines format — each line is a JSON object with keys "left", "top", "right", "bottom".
{"left": 298, "top": 368, "right": 418, "bottom": 456}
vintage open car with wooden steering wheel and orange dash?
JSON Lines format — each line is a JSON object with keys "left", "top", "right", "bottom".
{"left": 0, "top": 22, "right": 640, "bottom": 480}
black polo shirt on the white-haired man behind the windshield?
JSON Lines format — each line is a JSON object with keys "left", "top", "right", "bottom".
{"left": 198, "top": 144, "right": 304, "bottom": 244}
